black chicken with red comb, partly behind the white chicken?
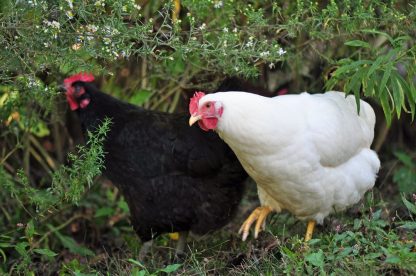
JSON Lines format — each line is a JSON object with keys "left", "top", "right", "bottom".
{"left": 64, "top": 73, "right": 247, "bottom": 259}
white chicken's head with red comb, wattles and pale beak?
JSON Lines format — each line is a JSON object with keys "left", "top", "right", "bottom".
{"left": 189, "top": 92, "right": 223, "bottom": 131}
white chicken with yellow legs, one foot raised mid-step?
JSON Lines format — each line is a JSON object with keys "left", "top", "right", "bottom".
{"left": 189, "top": 91, "right": 380, "bottom": 241}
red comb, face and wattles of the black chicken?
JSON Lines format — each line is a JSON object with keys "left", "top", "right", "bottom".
{"left": 64, "top": 73, "right": 94, "bottom": 110}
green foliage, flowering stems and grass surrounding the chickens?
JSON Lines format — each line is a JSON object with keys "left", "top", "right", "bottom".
{"left": 0, "top": 0, "right": 416, "bottom": 275}
